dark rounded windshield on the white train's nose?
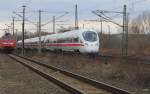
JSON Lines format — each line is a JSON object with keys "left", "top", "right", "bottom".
{"left": 83, "top": 31, "right": 97, "bottom": 42}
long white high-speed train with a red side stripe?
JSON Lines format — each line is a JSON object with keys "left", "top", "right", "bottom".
{"left": 18, "top": 29, "right": 99, "bottom": 53}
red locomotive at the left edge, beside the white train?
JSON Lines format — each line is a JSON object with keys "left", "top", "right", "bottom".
{"left": 0, "top": 33, "right": 16, "bottom": 51}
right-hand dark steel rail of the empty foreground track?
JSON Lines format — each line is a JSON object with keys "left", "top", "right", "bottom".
{"left": 9, "top": 53, "right": 131, "bottom": 94}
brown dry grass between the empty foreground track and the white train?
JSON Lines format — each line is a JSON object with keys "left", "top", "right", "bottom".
{"left": 23, "top": 53, "right": 150, "bottom": 94}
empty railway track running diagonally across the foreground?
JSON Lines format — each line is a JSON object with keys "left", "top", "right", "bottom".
{"left": 9, "top": 54, "right": 131, "bottom": 94}
